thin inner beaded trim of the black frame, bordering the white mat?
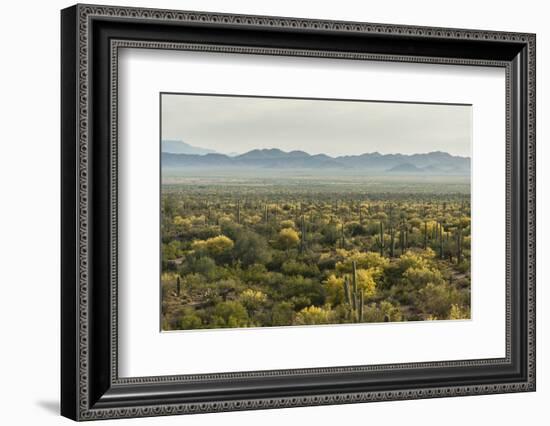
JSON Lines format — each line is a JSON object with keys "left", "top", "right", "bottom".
{"left": 111, "top": 39, "right": 511, "bottom": 384}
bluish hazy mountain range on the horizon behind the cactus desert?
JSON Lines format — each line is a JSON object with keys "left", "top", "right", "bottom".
{"left": 162, "top": 145, "right": 471, "bottom": 175}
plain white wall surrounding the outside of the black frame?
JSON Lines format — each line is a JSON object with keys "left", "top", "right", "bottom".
{"left": 0, "top": 0, "right": 550, "bottom": 426}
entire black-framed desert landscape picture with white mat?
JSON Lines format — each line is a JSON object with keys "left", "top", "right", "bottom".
{"left": 61, "top": 5, "right": 535, "bottom": 420}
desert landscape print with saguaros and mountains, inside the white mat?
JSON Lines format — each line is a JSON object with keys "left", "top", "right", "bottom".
{"left": 160, "top": 93, "right": 472, "bottom": 331}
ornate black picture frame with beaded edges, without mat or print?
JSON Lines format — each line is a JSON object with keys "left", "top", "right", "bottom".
{"left": 61, "top": 5, "right": 535, "bottom": 420}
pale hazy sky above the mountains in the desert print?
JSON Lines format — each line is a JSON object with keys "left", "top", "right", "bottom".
{"left": 162, "top": 94, "right": 472, "bottom": 157}
